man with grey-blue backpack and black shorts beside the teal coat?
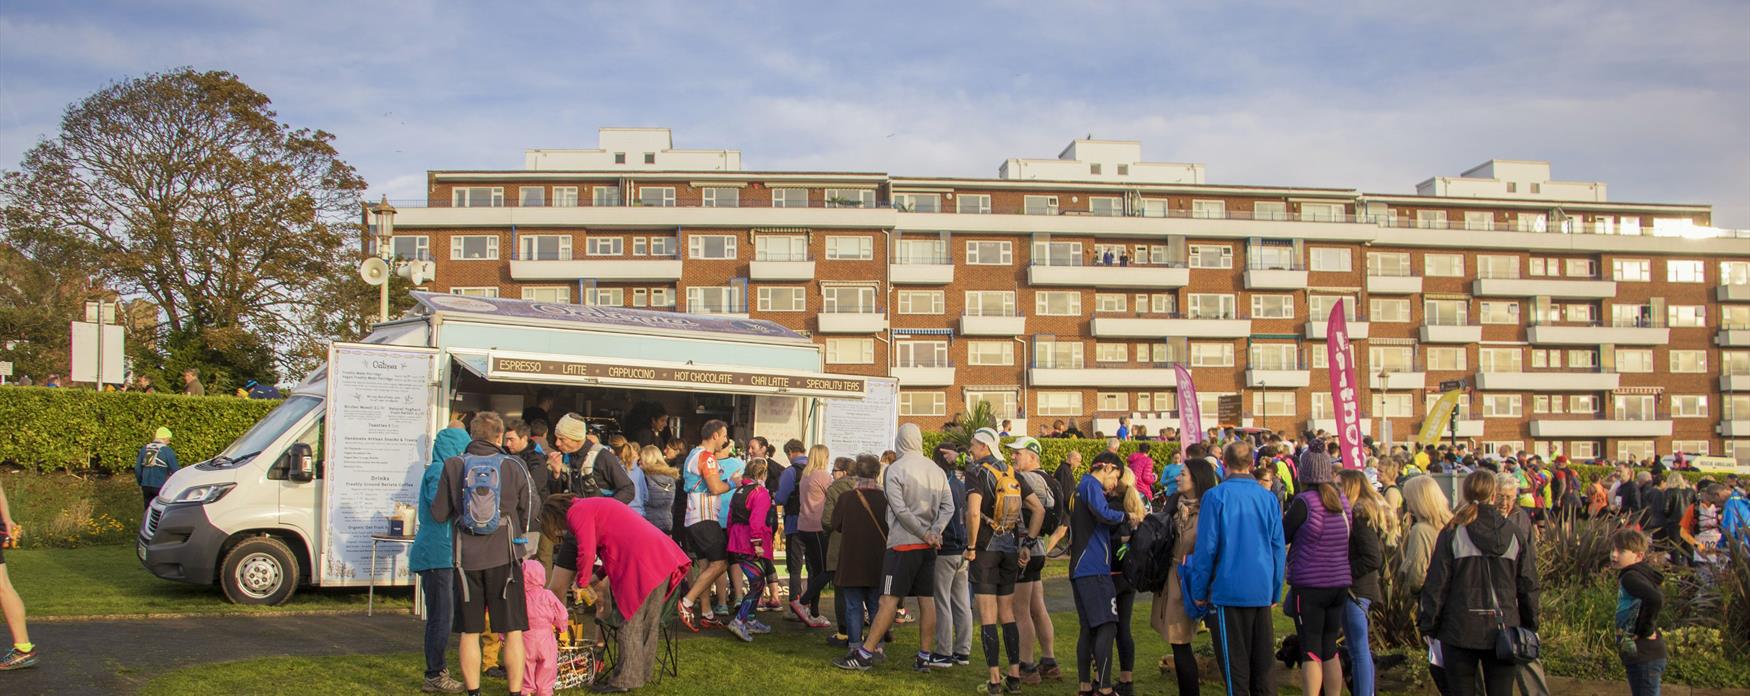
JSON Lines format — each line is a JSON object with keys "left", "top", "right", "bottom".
{"left": 432, "top": 411, "right": 537, "bottom": 693}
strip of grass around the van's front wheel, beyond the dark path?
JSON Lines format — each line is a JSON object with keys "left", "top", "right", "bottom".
{"left": 5, "top": 546, "right": 413, "bottom": 619}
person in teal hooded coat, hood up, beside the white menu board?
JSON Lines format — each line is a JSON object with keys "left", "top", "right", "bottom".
{"left": 408, "top": 421, "right": 471, "bottom": 694}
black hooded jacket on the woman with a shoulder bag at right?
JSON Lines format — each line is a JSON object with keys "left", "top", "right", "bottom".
{"left": 1416, "top": 505, "right": 1538, "bottom": 651}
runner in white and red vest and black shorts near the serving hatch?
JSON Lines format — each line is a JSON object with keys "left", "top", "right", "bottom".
{"left": 677, "top": 420, "right": 730, "bottom": 633}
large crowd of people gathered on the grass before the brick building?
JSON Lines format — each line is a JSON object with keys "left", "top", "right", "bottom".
{"left": 397, "top": 404, "right": 1750, "bottom": 694}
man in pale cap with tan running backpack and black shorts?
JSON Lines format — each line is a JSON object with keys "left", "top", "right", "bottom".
{"left": 966, "top": 428, "right": 1045, "bottom": 694}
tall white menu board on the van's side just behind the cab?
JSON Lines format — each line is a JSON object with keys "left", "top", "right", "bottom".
{"left": 319, "top": 343, "right": 438, "bottom": 586}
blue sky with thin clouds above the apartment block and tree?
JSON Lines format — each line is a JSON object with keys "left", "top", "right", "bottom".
{"left": 0, "top": 0, "right": 1750, "bottom": 227}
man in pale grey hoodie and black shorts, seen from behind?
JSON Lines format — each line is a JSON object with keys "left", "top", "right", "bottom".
{"left": 833, "top": 423, "right": 954, "bottom": 672}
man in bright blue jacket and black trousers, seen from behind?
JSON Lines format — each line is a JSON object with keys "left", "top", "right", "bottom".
{"left": 1187, "top": 442, "right": 1286, "bottom": 696}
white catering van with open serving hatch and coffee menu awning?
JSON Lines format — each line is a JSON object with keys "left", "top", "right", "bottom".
{"left": 138, "top": 292, "right": 882, "bottom": 603}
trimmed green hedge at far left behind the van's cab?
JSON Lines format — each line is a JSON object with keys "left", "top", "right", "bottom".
{"left": 0, "top": 386, "right": 280, "bottom": 472}
